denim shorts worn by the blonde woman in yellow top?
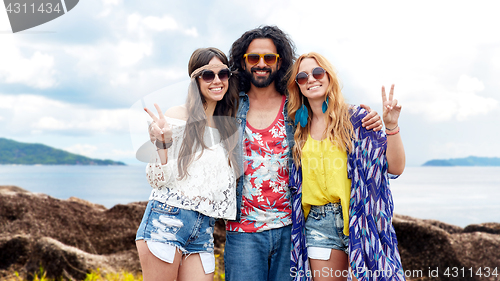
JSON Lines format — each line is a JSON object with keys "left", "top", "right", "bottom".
{"left": 306, "top": 203, "right": 349, "bottom": 260}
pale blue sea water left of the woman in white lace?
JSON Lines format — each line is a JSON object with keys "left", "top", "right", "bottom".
{"left": 0, "top": 164, "right": 151, "bottom": 208}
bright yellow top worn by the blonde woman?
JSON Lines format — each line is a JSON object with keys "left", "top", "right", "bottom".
{"left": 301, "top": 135, "right": 351, "bottom": 236}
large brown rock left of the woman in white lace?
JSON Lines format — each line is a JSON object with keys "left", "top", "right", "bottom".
{"left": 0, "top": 187, "right": 146, "bottom": 280}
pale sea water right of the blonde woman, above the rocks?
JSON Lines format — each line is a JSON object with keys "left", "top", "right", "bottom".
{"left": 390, "top": 167, "right": 500, "bottom": 227}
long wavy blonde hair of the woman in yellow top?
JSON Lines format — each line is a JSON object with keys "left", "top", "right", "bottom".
{"left": 288, "top": 52, "right": 354, "bottom": 166}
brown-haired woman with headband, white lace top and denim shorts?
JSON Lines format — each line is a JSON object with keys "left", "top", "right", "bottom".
{"left": 136, "top": 48, "right": 239, "bottom": 281}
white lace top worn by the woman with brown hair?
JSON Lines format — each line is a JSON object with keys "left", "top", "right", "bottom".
{"left": 146, "top": 117, "right": 236, "bottom": 220}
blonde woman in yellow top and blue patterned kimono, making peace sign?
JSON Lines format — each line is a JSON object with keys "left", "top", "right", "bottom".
{"left": 288, "top": 53, "right": 405, "bottom": 281}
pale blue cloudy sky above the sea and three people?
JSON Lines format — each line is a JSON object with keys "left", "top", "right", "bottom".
{"left": 0, "top": 0, "right": 500, "bottom": 166}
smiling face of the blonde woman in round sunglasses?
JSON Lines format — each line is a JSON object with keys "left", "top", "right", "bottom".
{"left": 299, "top": 58, "right": 330, "bottom": 101}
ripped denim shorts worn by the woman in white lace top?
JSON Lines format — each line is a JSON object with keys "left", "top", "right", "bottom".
{"left": 135, "top": 200, "right": 215, "bottom": 272}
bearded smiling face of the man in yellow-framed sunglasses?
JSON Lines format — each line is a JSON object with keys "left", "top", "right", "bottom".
{"left": 242, "top": 38, "right": 281, "bottom": 88}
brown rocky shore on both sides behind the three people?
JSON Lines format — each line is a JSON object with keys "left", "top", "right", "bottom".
{"left": 0, "top": 186, "right": 500, "bottom": 281}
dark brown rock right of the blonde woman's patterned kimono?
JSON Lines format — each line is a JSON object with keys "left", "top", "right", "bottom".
{"left": 393, "top": 215, "right": 500, "bottom": 281}
